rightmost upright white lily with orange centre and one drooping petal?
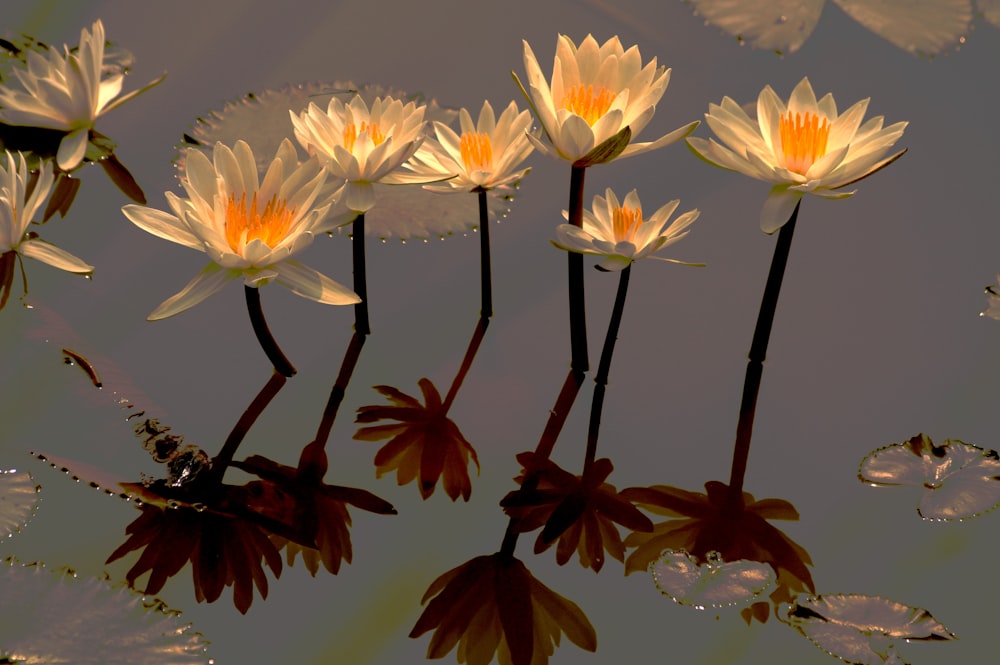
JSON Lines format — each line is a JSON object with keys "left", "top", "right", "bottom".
{"left": 687, "top": 78, "right": 907, "bottom": 233}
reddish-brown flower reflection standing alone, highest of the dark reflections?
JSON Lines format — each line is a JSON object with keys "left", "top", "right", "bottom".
{"left": 354, "top": 379, "right": 479, "bottom": 501}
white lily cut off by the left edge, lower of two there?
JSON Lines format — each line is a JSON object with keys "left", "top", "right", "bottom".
{"left": 0, "top": 152, "right": 94, "bottom": 309}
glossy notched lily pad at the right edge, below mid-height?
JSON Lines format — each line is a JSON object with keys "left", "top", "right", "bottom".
{"left": 858, "top": 434, "right": 1000, "bottom": 520}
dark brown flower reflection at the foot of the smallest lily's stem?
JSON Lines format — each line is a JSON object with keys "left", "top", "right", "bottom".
{"left": 500, "top": 452, "right": 653, "bottom": 572}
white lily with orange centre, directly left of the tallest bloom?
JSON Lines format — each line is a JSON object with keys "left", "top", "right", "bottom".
{"left": 407, "top": 101, "right": 534, "bottom": 192}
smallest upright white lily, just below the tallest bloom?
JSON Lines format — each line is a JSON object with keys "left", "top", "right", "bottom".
{"left": 552, "top": 188, "right": 701, "bottom": 271}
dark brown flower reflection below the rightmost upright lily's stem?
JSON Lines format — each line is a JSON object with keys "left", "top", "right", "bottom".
{"left": 621, "top": 481, "right": 816, "bottom": 622}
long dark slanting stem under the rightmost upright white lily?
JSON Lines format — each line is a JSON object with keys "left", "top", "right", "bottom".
{"left": 729, "top": 201, "right": 801, "bottom": 505}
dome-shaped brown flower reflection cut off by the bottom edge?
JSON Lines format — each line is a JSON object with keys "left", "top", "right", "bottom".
{"left": 410, "top": 553, "right": 597, "bottom": 665}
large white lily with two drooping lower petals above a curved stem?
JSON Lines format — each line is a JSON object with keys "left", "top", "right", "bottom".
{"left": 122, "top": 139, "right": 360, "bottom": 321}
